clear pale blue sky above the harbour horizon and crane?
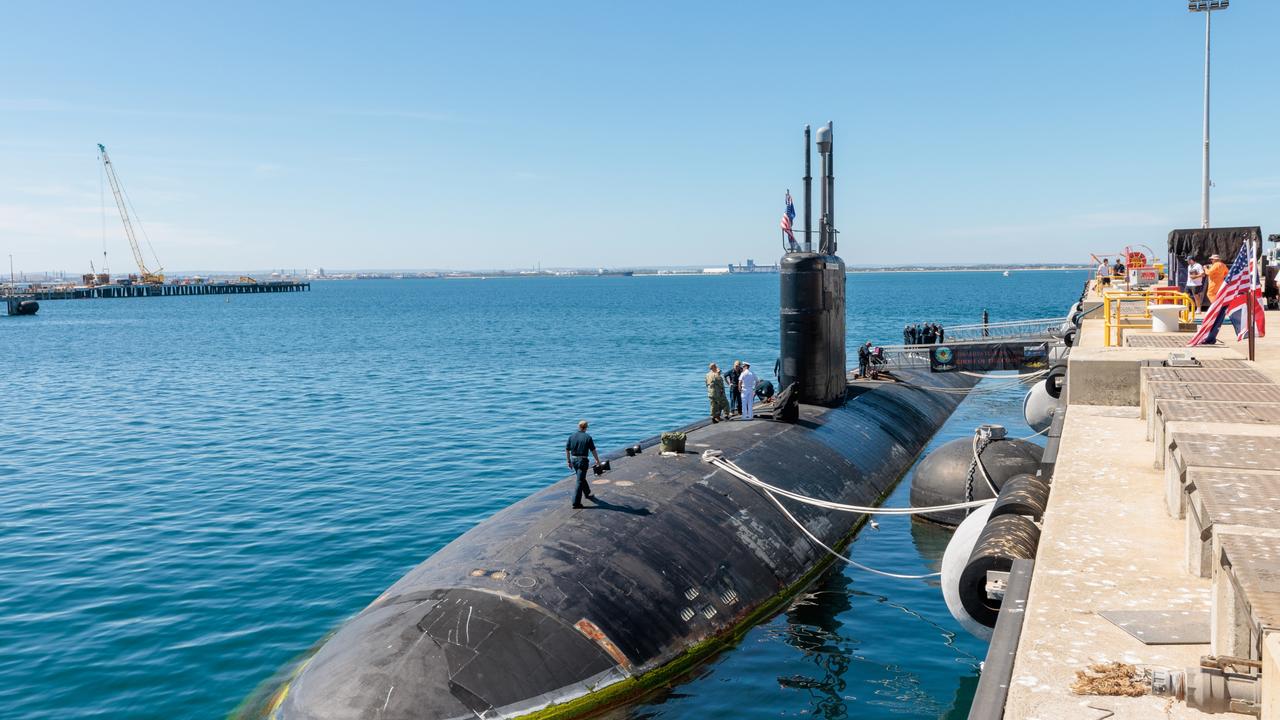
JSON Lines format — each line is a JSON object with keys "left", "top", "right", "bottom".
{"left": 0, "top": 0, "right": 1280, "bottom": 273}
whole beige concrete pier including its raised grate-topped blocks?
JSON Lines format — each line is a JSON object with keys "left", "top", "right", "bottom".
{"left": 993, "top": 283, "right": 1280, "bottom": 720}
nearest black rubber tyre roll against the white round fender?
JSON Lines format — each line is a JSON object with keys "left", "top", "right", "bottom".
{"left": 956, "top": 515, "right": 1039, "bottom": 628}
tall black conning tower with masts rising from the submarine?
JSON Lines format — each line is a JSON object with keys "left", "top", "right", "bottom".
{"left": 778, "top": 123, "right": 847, "bottom": 406}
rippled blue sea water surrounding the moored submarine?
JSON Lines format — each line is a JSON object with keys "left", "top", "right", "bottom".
{"left": 0, "top": 272, "right": 1085, "bottom": 719}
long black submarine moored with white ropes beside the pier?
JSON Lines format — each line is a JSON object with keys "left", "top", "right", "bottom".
{"left": 257, "top": 123, "right": 977, "bottom": 720}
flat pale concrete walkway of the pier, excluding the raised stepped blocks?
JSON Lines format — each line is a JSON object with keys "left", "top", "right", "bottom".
{"left": 998, "top": 283, "right": 1280, "bottom": 719}
